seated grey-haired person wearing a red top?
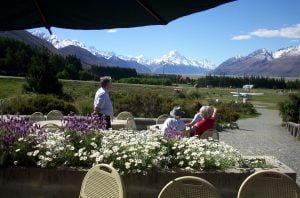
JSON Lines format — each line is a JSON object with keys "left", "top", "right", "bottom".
{"left": 194, "top": 106, "right": 217, "bottom": 137}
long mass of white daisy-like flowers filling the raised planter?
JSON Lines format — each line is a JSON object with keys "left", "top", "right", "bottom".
{"left": 0, "top": 117, "right": 266, "bottom": 174}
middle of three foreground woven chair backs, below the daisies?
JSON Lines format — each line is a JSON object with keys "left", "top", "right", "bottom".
{"left": 158, "top": 176, "right": 220, "bottom": 198}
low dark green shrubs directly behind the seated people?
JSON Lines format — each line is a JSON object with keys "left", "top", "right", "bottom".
{"left": 111, "top": 92, "right": 257, "bottom": 123}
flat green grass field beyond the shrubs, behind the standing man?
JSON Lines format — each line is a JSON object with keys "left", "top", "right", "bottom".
{"left": 0, "top": 78, "right": 296, "bottom": 113}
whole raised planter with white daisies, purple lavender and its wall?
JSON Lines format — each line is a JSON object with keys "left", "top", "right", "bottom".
{"left": 0, "top": 117, "right": 296, "bottom": 198}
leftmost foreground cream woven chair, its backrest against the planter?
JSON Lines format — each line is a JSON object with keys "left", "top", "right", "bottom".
{"left": 79, "top": 164, "right": 125, "bottom": 198}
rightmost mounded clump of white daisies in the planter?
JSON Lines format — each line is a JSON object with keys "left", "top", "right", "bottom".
{"left": 171, "top": 137, "right": 241, "bottom": 170}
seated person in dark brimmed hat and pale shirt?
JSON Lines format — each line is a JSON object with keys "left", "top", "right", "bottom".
{"left": 162, "top": 106, "right": 185, "bottom": 136}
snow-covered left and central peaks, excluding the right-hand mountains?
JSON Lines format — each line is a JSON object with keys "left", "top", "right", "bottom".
{"left": 31, "top": 30, "right": 216, "bottom": 74}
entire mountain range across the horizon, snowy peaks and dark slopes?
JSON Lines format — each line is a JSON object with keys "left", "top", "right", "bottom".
{"left": 0, "top": 30, "right": 300, "bottom": 76}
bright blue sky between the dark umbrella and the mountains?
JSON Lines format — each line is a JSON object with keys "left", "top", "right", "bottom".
{"left": 32, "top": 0, "right": 300, "bottom": 64}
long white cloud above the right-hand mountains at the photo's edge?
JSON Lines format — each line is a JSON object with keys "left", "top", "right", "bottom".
{"left": 231, "top": 24, "right": 300, "bottom": 40}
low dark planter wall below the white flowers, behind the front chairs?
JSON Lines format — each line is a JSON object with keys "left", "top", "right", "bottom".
{"left": 0, "top": 158, "right": 296, "bottom": 198}
